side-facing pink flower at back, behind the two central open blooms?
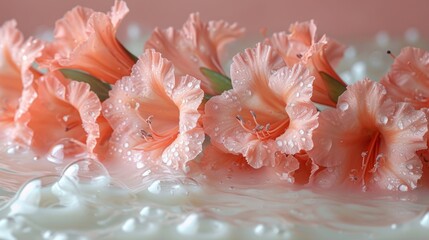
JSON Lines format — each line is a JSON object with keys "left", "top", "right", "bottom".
{"left": 145, "top": 13, "right": 244, "bottom": 95}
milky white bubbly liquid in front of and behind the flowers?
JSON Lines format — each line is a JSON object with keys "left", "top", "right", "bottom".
{"left": 0, "top": 29, "right": 429, "bottom": 240}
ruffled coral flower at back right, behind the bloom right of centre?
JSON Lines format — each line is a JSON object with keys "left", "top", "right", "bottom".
{"left": 266, "top": 21, "right": 346, "bottom": 107}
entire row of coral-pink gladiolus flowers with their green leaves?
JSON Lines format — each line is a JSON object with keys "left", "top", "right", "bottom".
{"left": 0, "top": 1, "right": 429, "bottom": 191}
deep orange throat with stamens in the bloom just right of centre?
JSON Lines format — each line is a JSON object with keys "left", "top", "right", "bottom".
{"left": 236, "top": 110, "right": 290, "bottom": 140}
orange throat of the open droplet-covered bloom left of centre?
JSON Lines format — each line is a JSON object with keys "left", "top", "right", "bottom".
{"left": 137, "top": 116, "right": 179, "bottom": 152}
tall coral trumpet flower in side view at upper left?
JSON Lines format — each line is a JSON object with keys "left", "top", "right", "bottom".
{"left": 38, "top": 1, "right": 134, "bottom": 83}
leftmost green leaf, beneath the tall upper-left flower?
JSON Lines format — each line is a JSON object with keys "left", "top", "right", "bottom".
{"left": 60, "top": 69, "right": 112, "bottom": 102}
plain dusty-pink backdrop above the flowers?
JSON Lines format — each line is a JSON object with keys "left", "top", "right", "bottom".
{"left": 0, "top": 0, "right": 429, "bottom": 40}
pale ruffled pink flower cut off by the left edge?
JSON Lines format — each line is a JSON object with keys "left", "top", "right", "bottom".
{"left": 0, "top": 21, "right": 43, "bottom": 145}
